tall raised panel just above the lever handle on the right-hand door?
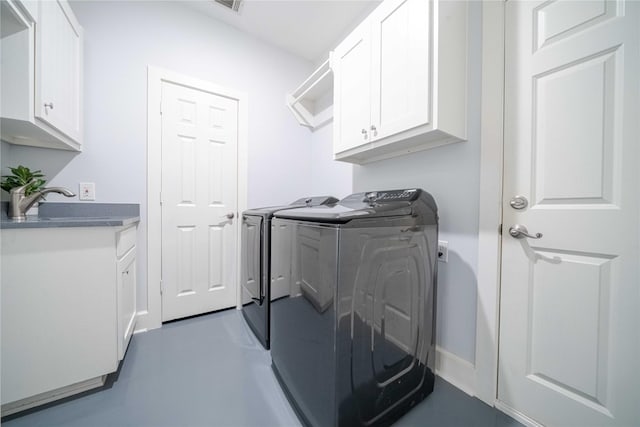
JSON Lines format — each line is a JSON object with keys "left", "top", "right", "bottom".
{"left": 532, "top": 48, "right": 622, "bottom": 204}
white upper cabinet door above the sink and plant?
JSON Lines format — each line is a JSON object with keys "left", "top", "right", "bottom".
{"left": 35, "top": 1, "right": 82, "bottom": 141}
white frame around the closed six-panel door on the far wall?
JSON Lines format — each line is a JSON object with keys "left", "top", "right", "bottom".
{"left": 136, "top": 66, "right": 249, "bottom": 332}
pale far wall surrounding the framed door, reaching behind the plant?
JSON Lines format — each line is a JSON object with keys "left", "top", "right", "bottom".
{"left": 2, "top": 1, "right": 320, "bottom": 320}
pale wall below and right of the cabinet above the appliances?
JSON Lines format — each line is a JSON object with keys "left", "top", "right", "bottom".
{"left": 354, "top": 2, "right": 482, "bottom": 363}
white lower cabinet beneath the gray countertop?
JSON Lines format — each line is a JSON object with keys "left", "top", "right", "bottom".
{"left": 1, "top": 225, "right": 136, "bottom": 416}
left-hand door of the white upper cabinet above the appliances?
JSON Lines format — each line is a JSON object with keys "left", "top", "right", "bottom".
{"left": 331, "top": 22, "right": 371, "bottom": 152}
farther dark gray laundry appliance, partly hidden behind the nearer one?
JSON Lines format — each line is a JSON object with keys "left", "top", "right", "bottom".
{"left": 241, "top": 196, "right": 338, "bottom": 350}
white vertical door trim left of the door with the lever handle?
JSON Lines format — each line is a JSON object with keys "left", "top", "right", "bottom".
{"left": 471, "top": 0, "right": 502, "bottom": 412}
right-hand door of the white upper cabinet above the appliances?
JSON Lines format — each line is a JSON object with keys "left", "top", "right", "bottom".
{"left": 371, "top": 0, "right": 431, "bottom": 139}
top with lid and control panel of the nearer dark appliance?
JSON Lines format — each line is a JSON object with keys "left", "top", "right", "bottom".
{"left": 274, "top": 188, "right": 437, "bottom": 224}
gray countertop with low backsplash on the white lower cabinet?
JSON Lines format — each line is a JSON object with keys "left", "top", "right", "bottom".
{"left": 0, "top": 202, "right": 140, "bottom": 229}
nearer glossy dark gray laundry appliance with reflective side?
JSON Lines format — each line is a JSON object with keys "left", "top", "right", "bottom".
{"left": 271, "top": 189, "right": 438, "bottom": 427}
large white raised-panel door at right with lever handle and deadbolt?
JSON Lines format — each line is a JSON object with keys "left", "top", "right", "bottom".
{"left": 498, "top": 1, "right": 640, "bottom": 427}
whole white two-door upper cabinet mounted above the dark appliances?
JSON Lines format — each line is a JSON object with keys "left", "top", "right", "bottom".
{"left": 332, "top": 0, "right": 467, "bottom": 163}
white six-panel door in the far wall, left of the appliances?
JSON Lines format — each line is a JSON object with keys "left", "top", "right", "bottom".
{"left": 162, "top": 82, "right": 238, "bottom": 321}
